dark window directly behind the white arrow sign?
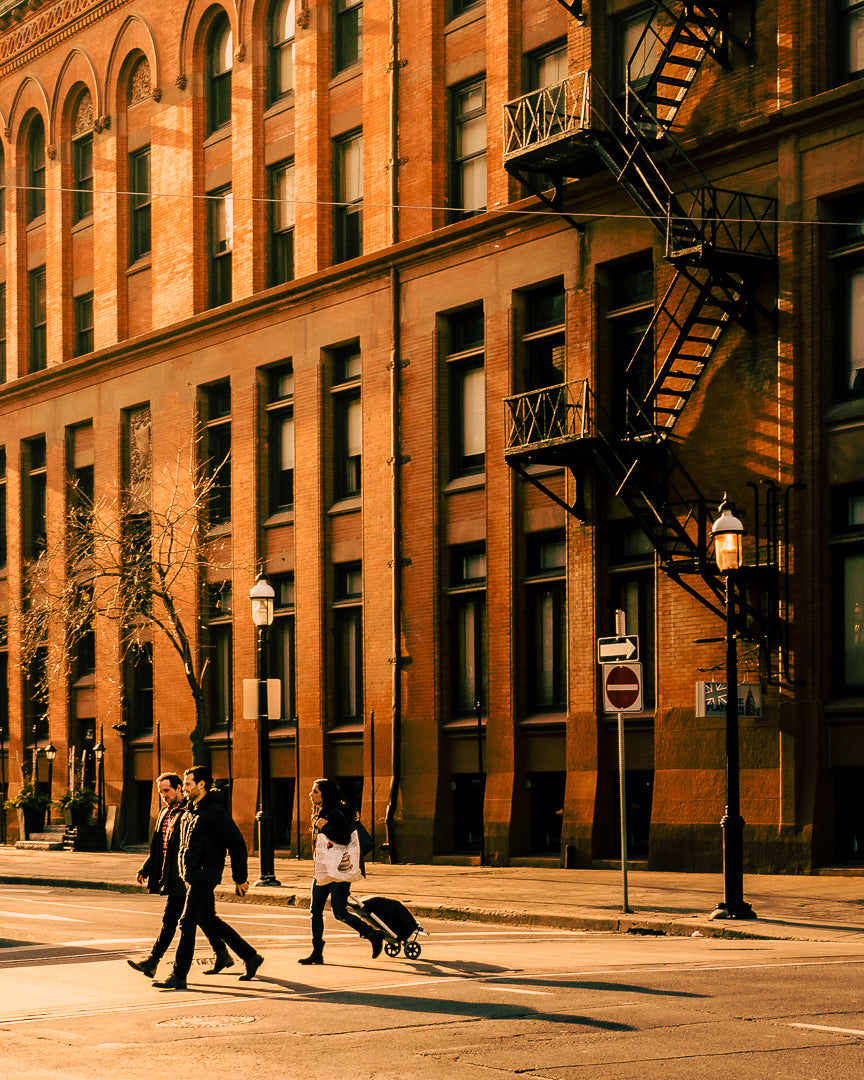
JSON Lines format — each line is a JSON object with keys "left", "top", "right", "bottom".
{"left": 606, "top": 522, "right": 656, "bottom": 710}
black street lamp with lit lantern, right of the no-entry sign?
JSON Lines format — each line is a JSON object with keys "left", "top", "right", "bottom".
{"left": 711, "top": 496, "right": 756, "bottom": 919}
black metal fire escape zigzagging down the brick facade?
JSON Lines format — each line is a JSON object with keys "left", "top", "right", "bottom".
{"left": 504, "top": 0, "right": 777, "bottom": 615}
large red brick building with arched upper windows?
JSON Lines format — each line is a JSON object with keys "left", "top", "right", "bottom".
{"left": 0, "top": 0, "right": 864, "bottom": 872}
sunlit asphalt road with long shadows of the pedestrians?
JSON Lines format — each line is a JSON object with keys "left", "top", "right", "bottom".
{"left": 0, "top": 886, "right": 864, "bottom": 1080}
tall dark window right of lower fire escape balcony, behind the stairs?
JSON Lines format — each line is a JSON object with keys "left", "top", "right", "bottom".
{"left": 606, "top": 258, "right": 654, "bottom": 434}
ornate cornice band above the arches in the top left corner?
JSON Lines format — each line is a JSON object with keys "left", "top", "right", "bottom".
{"left": 0, "top": 0, "right": 129, "bottom": 78}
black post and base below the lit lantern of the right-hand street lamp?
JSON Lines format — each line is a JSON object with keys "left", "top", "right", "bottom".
{"left": 711, "top": 570, "right": 756, "bottom": 919}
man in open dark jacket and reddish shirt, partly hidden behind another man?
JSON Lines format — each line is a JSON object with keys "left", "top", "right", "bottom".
{"left": 126, "top": 772, "right": 234, "bottom": 978}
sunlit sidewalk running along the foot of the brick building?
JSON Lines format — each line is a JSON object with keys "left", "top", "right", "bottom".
{"left": 0, "top": 848, "right": 864, "bottom": 945}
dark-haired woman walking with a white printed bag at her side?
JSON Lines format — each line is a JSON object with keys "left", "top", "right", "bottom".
{"left": 297, "top": 779, "right": 383, "bottom": 963}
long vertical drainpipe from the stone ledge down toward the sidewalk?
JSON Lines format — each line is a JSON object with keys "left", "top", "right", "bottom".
{"left": 386, "top": 267, "right": 407, "bottom": 863}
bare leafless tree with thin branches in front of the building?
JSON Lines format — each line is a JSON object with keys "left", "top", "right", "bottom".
{"left": 19, "top": 419, "right": 243, "bottom": 760}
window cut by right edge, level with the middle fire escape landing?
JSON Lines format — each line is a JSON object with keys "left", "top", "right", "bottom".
{"left": 828, "top": 195, "right": 864, "bottom": 397}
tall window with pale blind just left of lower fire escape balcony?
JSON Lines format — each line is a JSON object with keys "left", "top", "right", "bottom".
{"left": 447, "top": 306, "right": 486, "bottom": 478}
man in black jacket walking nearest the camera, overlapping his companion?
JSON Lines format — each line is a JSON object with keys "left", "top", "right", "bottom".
{"left": 153, "top": 765, "right": 264, "bottom": 990}
